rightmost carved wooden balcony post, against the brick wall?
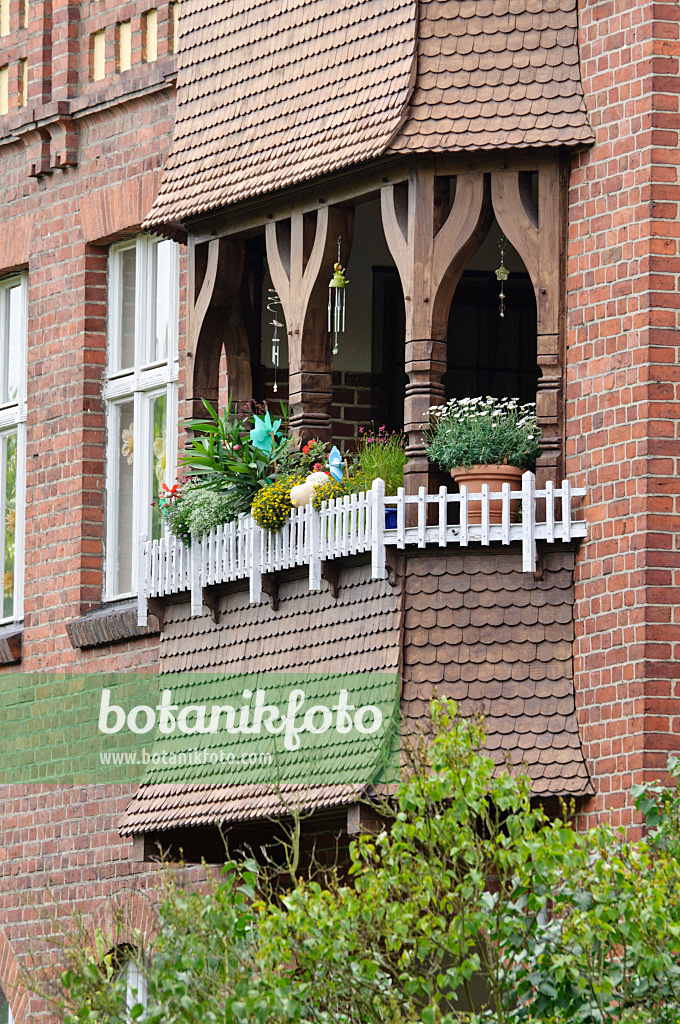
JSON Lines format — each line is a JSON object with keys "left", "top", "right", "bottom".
{"left": 492, "top": 160, "right": 566, "bottom": 487}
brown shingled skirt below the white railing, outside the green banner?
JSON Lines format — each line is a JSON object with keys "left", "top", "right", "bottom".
{"left": 121, "top": 549, "right": 592, "bottom": 835}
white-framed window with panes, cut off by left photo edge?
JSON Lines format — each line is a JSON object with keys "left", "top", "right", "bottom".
{"left": 0, "top": 274, "right": 28, "bottom": 622}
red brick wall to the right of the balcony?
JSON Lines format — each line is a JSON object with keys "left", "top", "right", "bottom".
{"left": 566, "top": 0, "right": 680, "bottom": 825}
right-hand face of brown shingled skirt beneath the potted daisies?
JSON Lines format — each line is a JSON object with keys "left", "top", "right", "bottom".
{"left": 402, "top": 549, "right": 593, "bottom": 799}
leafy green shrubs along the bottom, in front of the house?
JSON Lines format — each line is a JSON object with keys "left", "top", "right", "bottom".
{"left": 23, "top": 700, "right": 680, "bottom": 1024}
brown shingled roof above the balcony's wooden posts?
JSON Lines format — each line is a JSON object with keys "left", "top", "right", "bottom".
{"left": 145, "top": 0, "right": 593, "bottom": 227}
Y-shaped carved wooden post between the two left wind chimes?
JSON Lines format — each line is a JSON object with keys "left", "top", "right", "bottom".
{"left": 265, "top": 206, "right": 354, "bottom": 440}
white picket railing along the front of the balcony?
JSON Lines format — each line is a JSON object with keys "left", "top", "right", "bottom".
{"left": 137, "top": 472, "right": 586, "bottom": 626}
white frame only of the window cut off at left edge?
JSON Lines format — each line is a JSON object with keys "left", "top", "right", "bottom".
{"left": 0, "top": 271, "right": 29, "bottom": 625}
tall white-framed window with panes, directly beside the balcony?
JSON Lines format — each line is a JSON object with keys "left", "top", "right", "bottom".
{"left": 104, "top": 236, "right": 179, "bottom": 600}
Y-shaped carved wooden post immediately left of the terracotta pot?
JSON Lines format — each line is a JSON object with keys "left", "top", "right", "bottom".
{"left": 381, "top": 166, "right": 492, "bottom": 494}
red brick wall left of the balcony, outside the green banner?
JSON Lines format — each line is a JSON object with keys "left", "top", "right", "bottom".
{"left": 0, "top": 6, "right": 185, "bottom": 1022}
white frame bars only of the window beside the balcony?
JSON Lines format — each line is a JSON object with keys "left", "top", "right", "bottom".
{"left": 103, "top": 234, "right": 179, "bottom": 601}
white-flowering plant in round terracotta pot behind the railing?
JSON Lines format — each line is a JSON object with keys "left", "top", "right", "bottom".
{"left": 425, "top": 396, "right": 541, "bottom": 523}
